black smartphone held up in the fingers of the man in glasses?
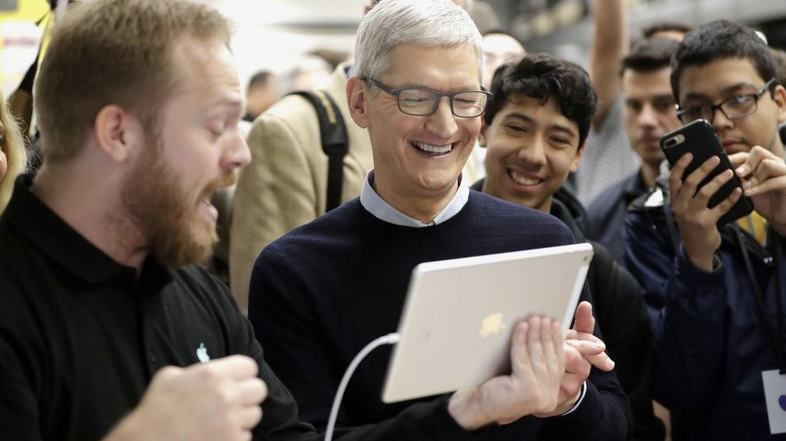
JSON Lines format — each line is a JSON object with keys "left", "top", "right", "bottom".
{"left": 660, "top": 119, "right": 753, "bottom": 227}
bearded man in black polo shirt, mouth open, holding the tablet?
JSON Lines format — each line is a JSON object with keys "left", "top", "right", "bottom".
{"left": 0, "top": 0, "right": 624, "bottom": 441}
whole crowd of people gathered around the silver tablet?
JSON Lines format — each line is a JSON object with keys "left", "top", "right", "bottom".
{"left": 0, "top": 0, "right": 786, "bottom": 441}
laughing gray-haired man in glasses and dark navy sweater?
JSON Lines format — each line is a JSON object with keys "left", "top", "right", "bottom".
{"left": 249, "top": 0, "right": 631, "bottom": 441}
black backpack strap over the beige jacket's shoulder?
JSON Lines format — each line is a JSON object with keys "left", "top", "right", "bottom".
{"left": 290, "top": 90, "right": 349, "bottom": 211}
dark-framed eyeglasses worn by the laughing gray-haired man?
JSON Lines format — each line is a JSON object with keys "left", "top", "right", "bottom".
{"left": 364, "top": 78, "right": 492, "bottom": 118}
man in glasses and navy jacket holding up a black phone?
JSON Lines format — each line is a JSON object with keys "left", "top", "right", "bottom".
{"left": 626, "top": 21, "right": 786, "bottom": 441}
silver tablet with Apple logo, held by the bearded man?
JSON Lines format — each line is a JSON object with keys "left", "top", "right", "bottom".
{"left": 382, "top": 243, "right": 592, "bottom": 403}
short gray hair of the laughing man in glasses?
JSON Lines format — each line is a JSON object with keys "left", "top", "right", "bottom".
{"left": 355, "top": 0, "right": 483, "bottom": 82}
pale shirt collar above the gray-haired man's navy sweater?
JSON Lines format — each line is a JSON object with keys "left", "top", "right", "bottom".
{"left": 360, "top": 170, "right": 469, "bottom": 228}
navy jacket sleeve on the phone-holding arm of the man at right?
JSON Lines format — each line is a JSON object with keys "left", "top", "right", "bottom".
{"left": 626, "top": 208, "right": 727, "bottom": 416}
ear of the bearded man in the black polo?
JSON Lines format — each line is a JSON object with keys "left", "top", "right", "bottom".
{"left": 93, "top": 104, "right": 143, "bottom": 162}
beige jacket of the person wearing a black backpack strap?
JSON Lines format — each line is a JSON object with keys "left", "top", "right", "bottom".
{"left": 229, "top": 64, "right": 373, "bottom": 312}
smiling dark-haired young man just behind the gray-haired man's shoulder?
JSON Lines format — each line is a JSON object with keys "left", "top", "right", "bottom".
{"left": 473, "top": 54, "right": 665, "bottom": 440}
